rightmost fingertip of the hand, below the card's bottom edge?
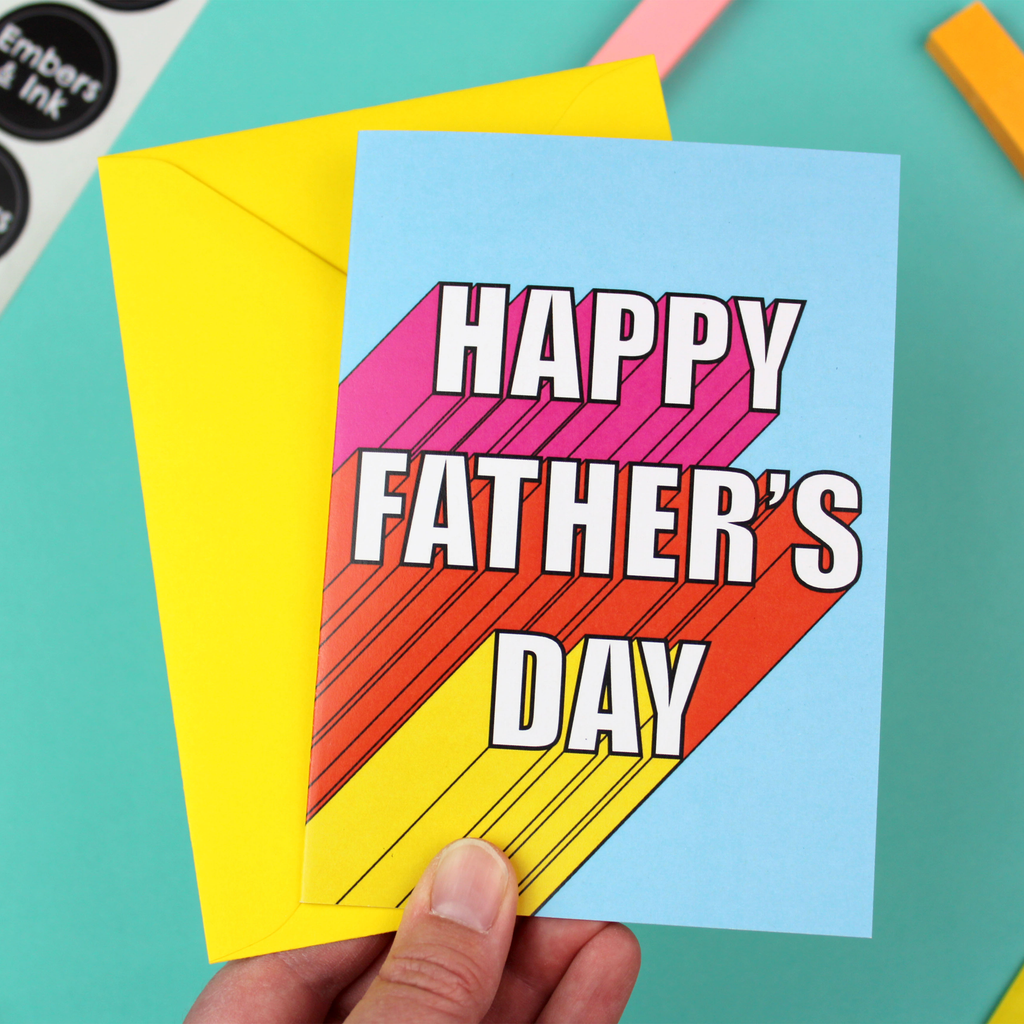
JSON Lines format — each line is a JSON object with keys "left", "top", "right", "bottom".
{"left": 537, "top": 925, "right": 640, "bottom": 1024}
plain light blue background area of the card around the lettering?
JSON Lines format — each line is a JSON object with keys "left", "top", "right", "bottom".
{"left": 341, "top": 132, "right": 899, "bottom": 936}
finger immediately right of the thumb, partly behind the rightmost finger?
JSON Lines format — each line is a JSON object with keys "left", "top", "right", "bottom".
{"left": 484, "top": 918, "right": 608, "bottom": 1024}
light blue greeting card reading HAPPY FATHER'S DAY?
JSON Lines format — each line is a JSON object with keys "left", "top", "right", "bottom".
{"left": 303, "top": 132, "right": 899, "bottom": 936}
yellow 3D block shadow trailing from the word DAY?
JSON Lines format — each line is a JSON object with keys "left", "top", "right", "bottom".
{"left": 302, "top": 637, "right": 680, "bottom": 914}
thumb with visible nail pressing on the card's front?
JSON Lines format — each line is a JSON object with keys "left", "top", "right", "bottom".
{"left": 347, "top": 839, "right": 519, "bottom": 1024}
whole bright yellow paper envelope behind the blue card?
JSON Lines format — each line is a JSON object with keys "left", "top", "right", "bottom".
{"left": 100, "top": 57, "right": 671, "bottom": 962}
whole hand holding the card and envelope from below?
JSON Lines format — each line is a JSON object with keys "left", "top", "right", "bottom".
{"left": 185, "top": 839, "right": 640, "bottom": 1024}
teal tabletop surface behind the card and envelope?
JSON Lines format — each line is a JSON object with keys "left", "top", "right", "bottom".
{"left": 0, "top": 0, "right": 1024, "bottom": 1024}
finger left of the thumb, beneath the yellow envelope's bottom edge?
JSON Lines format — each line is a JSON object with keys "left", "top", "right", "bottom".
{"left": 185, "top": 935, "right": 390, "bottom": 1024}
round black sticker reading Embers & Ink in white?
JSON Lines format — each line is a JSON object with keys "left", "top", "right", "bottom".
{"left": 0, "top": 3, "right": 118, "bottom": 139}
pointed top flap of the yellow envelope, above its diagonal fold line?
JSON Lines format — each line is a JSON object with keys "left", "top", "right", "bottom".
{"left": 123, "top": 57, "right": 672, "bottom": 270}
